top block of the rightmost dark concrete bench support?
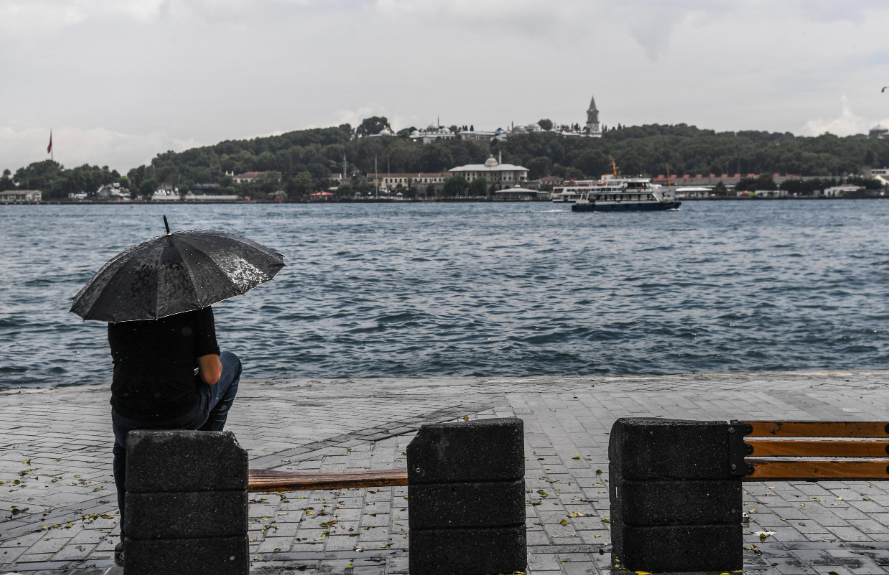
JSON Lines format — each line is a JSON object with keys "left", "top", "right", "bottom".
{"left": 608, "top": 417, "right": 731, "bottom": 480}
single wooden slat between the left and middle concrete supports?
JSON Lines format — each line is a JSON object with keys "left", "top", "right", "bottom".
{"left": 248, "top": 469, "right": 407, "bottom": 492}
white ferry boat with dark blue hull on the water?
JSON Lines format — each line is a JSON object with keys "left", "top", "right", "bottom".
{"left": 571, "top": 159, "right": 682, "bottom": 212}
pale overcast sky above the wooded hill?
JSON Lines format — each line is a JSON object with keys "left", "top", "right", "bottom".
{"left": 0, "top": 0, "right": 889, "bottom": 171}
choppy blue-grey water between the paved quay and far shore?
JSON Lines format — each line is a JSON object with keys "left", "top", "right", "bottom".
{"left": 0, "top": 200, "right": 889, "bottom": 386}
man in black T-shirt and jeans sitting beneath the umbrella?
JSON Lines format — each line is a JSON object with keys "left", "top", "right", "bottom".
{"left": 108, "top": 307, "right": 242, "bottom": 565}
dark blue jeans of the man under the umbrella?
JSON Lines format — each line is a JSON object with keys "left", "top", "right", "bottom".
{"left": 111, "top": 351, "right": 241, "bottom": 541}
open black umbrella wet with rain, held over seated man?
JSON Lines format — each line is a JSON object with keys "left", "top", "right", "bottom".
{"left": 71, "top": 216, "right": 284, "bottom": 323}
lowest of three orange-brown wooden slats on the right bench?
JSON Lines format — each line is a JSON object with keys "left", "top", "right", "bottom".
{"left": 743, "top": 459, "right": 889, "bottom": 481}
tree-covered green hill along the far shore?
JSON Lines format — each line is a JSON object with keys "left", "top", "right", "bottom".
{"left": 8, "top": 118, "right": 889, "bottom": 199}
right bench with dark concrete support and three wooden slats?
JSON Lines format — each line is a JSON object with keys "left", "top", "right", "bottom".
{"left": 609, "top": 417, "right": 889, "bottom": 572}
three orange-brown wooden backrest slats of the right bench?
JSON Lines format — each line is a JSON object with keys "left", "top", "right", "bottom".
{"left": 732, "top": 421, "right": 889, "bottom": 481}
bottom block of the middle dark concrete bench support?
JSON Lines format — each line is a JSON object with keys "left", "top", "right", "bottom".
{"left": 410, "top": 528, "right": 528, "bottom": 575}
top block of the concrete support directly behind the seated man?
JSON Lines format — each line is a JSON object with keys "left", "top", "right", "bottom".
{"left": 126, "top": 430, "right": 248, "bottom": 493}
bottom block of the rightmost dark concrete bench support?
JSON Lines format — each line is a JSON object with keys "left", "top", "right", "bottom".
{"left": 611, "top": 523, "right": 744, "bottom": 573}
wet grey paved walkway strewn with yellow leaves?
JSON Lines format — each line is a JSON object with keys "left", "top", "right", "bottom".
{"left": 0, "top": 372, "right": 889, "bottom": 575}
